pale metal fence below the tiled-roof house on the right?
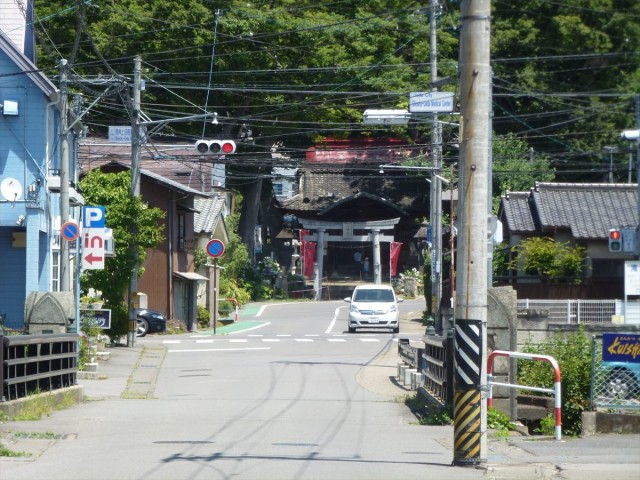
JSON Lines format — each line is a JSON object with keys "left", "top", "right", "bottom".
{"left": 518, "top": 299, "right": 617, "bottom": 324}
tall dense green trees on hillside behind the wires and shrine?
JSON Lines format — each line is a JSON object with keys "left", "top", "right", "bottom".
{"left": 36, "top": 0, "right": 640, "bottom": 256}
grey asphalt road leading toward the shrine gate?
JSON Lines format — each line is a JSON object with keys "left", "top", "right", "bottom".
{"left": 0, "top": 301, "right": 482, "bottom": 480}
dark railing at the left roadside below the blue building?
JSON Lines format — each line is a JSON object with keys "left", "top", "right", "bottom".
{"left": 0, "top": 334, "right": 79, "bottom": 401}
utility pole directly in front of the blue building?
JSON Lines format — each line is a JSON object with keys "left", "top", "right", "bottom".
{"left": 58, "top": 59, "right": 71, "bottom": 292}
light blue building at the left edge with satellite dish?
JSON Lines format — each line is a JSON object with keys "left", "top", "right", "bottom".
{"left": 0, "top": 23, "right": 73, "bottom": 330}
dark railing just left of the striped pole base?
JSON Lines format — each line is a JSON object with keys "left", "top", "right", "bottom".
{"left": 423, "top": 335, "right": 454, "bottom": 405}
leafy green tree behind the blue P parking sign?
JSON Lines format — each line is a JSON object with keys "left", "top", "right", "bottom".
{"left": 80, "top": 169, "right": 164, "bottom": 339}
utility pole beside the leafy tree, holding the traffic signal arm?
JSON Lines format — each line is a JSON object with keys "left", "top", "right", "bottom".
{"left": 127, "top": 55, "right": 142, "bottom": 347}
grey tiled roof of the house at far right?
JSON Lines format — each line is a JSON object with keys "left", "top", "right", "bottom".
{"left": 502, "top": 183, "right": 638, "bottom": 240}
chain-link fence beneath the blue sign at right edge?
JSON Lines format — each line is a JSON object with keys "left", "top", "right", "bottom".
{"left": 591, "top": 335, "right": 640, "bottom": 410}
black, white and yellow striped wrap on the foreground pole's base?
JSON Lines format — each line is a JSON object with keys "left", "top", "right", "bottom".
{"left": 453, "top": 320, "right": 483, "bottom": 465}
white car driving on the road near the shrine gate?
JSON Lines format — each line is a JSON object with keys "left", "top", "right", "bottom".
{"left": 344, "top": 284, "right": 402, "bottom": 333}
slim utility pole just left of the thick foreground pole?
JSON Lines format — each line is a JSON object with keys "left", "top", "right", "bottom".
{"left": 429, "top": 0, "right": 442, "bottom": 324}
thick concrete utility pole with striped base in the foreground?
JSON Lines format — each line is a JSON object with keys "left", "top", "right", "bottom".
{"left": 453, "top": 0, "right": 491, "bottom": 466}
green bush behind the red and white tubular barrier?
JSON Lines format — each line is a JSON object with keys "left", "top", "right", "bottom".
{"left": 518, "top": 328, "right": 591, "bottom": 436}
